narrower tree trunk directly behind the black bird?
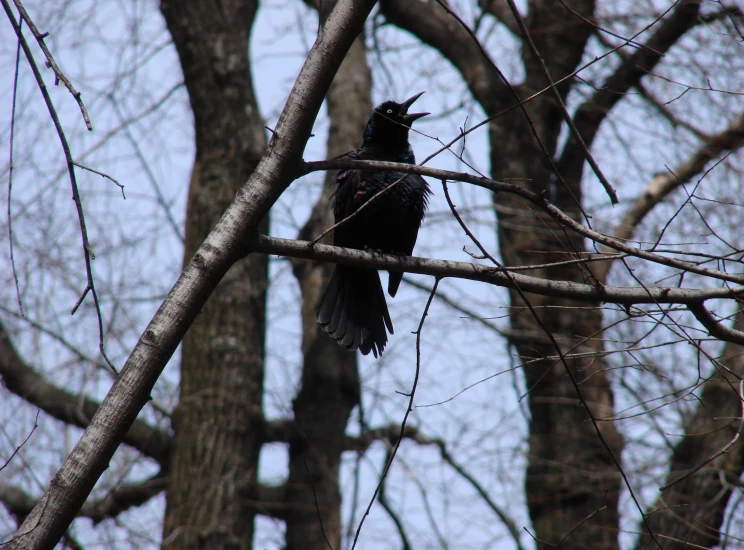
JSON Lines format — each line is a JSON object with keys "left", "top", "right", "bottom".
{"left": 286, "top": 2, "right": 372, "bottom": 550}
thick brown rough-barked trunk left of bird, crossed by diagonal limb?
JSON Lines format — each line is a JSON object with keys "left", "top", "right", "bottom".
{"left": 161, "top": 0, "right": 268, "bottom": 549}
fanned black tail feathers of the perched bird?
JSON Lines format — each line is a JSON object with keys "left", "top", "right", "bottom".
{"left": 315, "top": 265, "right": 393, "bottom": 357}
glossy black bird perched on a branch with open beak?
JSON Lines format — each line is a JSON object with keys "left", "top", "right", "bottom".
{"left": 315, "top": 92, "right": 431, "bottom": 357}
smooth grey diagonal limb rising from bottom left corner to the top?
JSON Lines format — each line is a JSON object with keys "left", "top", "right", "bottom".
{"left": 8, "top": 0, "right": 375, "bottom": 549}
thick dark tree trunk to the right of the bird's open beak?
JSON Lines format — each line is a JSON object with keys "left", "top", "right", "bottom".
{"left": 490, "top": 1, "right": 622, "bottom": 550}
